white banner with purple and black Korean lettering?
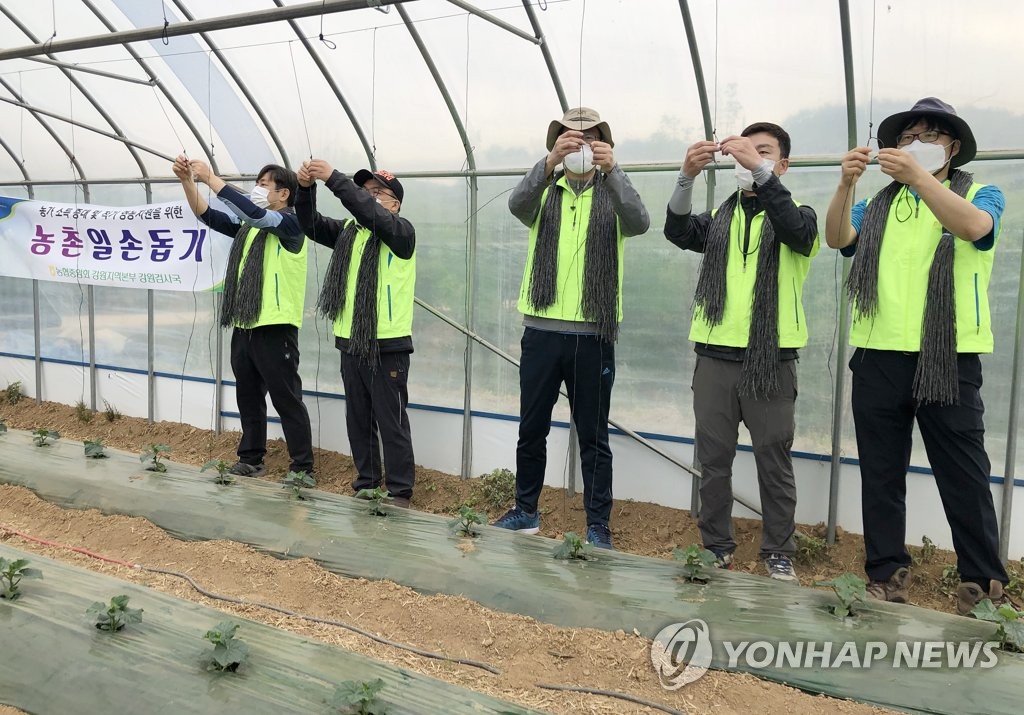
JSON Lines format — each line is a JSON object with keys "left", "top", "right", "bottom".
{"left": 0, "top": 197, "right": 231, "bottom": 291}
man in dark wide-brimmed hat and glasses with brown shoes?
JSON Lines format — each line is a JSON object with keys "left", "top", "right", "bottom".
{"left": 825, "top": 97, "right": 1009, "bottom": 616}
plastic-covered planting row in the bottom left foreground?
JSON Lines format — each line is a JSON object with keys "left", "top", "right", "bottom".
{"left": 0, "top": 545, "right": 536, "bottom": 715}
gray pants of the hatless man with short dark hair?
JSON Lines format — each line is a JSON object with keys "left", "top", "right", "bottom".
{"left": 691, "top": 355, "right": 797, "bottom": 558}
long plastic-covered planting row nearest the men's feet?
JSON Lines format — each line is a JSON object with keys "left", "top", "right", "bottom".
{"left": 0, "top": 431, "right": 1024, "bottom": 714}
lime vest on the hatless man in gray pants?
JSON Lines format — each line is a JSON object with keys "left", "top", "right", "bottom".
{"left": 689, "top": 198, "right": 819, "bottom": 347}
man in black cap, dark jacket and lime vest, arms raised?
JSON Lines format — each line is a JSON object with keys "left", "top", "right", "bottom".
{"left": 295, "top": 159, "right": 416, "bottom": 507}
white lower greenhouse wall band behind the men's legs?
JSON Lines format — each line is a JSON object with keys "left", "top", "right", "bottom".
{"left": 0, "top": 353, "right": 1024, "bottom": 559}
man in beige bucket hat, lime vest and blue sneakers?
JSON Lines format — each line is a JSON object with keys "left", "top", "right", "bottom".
{"left": 495, "top": 107, "right": 650, "bottom": 549}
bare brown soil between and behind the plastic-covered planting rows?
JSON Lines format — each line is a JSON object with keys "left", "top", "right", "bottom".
{"left": 0, "top": 399, "right": 983, "bottom": 715}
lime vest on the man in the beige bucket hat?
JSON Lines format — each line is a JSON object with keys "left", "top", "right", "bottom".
{"left": 518, "top": 175, "right": 625, "bottom": 323}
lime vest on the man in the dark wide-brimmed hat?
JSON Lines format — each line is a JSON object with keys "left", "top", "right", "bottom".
{"left": 850, "top": 180, "right": 998, "bottom": 352}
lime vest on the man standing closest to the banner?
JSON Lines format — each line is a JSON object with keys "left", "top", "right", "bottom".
{"left": 239, "top": 226, "right": 308, "bottom": 328}
